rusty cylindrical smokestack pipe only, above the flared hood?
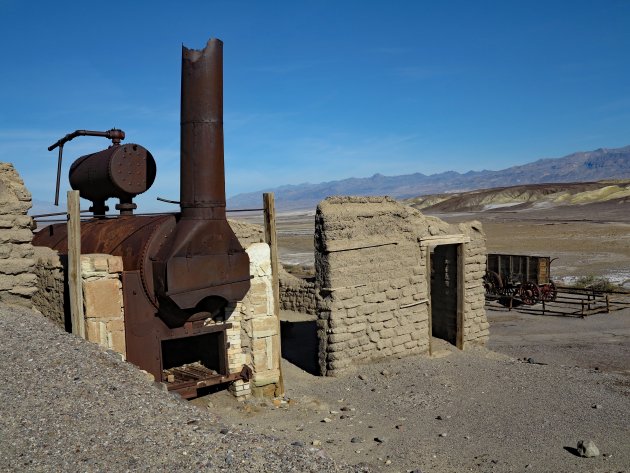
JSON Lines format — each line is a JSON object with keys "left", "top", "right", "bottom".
{"left": 180, "top": 39, "right": 225, "bottom": 218}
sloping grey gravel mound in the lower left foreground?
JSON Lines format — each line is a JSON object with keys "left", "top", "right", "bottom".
{"left": 0, "top": 306, "right": 360, "bottom": 472}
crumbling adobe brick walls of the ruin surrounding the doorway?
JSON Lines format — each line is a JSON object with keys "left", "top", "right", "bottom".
{"left": 315, "top": 197, "right": 488, "bottom": 375}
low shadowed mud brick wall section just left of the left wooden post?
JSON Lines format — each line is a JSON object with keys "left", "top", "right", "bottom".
{"left": 33, "top": 246, "right": 65, "bottom": 328}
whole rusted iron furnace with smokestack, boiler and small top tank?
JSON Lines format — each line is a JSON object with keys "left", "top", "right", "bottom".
{"left": 34, "top": 39, "right": 250, "bottom": 390}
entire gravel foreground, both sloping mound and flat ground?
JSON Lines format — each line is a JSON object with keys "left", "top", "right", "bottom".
{"left": 0, "top": 306, "right": 630, "bottom": 473}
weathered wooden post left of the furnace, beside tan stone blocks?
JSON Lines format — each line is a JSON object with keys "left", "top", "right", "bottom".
{"left": 68, "top": 191, "right": 85, "bottom": 338}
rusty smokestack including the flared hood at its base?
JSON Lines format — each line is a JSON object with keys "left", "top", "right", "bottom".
{"left": 153, "top": 39, "right": 250, "bottom": 328}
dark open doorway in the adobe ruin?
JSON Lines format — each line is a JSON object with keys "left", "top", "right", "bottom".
{"left": 430, "top": 245, "right": 460, "bottom": 345}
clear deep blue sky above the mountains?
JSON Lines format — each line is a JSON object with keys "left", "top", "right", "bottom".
{"left": 0, "top": 0, "right": 630, "bottom": 210}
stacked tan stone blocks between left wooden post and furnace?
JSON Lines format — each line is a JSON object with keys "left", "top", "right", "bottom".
{"left": 81, "top": 254, "right": 127, "bottom": 357}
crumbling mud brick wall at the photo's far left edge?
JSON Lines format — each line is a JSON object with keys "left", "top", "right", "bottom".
{"left": 0, "top": 163, "right": 37, "bottom": 307}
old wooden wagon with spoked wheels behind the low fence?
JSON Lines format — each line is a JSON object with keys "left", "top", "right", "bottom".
{"left": 483, "top": 253, "right": 558, "bottom": 305}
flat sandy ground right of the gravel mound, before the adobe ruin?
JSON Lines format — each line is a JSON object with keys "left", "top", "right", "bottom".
{"left": 201, "top": 309, "right": 630, "bottom": 472}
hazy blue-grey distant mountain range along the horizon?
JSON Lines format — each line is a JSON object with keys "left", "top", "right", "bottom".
{"left": 228, "top": 146, "right": 630, "bottom": 210}
